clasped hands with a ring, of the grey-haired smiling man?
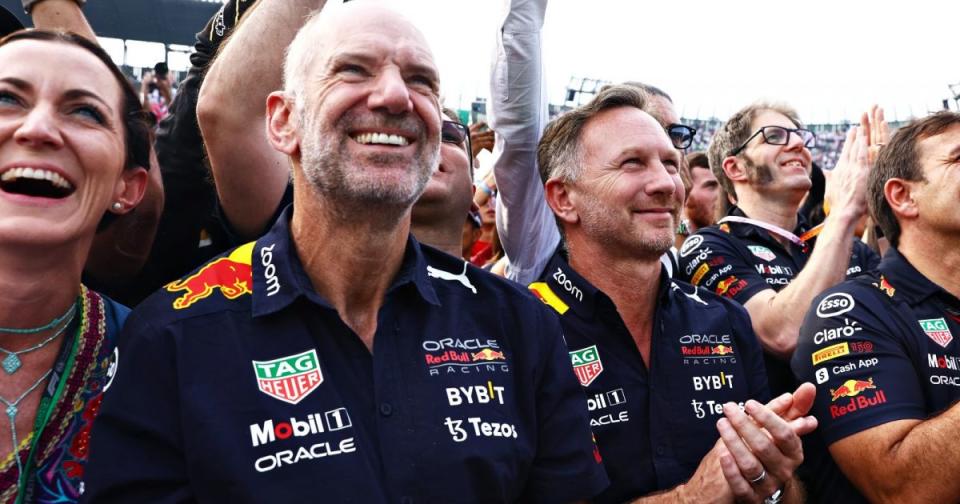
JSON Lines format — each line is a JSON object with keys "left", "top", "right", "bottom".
{"left": 717, "top": 383, "right": 817, "bottom": 503}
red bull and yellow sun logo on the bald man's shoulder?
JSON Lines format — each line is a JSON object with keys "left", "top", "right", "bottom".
{"left": 166, "top": 242, "right": 254, "bottom": 310}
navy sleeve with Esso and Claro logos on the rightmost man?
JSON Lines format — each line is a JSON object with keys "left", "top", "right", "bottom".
{"left": 791, "top": 280, "right": 926, "bottom": 446}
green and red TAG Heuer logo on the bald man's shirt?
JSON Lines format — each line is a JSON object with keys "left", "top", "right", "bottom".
{"left": 253, "top": 350, "right": 323, "bottom": 404}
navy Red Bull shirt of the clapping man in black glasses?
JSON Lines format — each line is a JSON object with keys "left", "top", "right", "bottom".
{"left": 678, "top": 207, "right": 880, "bottom": 394}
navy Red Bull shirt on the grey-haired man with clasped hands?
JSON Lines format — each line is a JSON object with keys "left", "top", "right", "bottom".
{"left": 530, "top": 251, "right": 769, "bottom": 502}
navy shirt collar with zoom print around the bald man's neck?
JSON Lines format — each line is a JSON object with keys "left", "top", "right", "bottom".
{"left": 252, "top": 205, "right": 440, "bottom": 317}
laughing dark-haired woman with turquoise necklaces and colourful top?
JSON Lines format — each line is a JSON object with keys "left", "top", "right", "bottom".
{"left": 0, "top": 31, "right": 149, "bottom": 503}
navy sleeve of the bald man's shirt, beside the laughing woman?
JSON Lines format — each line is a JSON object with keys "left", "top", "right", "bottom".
{"left": 83, "top": 312, "right": 195, "bottom": 503}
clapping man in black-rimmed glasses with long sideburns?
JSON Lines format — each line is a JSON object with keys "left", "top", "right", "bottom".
{"left": 680, "top": 103, "right": 879, "bottom": 394}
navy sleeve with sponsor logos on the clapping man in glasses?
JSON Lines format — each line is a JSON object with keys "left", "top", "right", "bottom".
{"left": 678, "top": 228, "right": 770, "bottom": 304}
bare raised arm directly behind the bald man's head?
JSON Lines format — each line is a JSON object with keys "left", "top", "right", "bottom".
{"left": 197, "top": 0, "right": 325, "bottom": 238}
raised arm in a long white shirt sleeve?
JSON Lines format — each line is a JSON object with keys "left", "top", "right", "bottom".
{"left": 490, "top": 0, "right": 560, "bottom": 285}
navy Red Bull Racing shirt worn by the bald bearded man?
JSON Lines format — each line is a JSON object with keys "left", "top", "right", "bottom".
{"left": 86, "top": 210, "right": 607, "bottom": 504}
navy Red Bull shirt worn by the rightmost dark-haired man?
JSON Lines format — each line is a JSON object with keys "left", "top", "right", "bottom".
{"left": 792, "top": 249, "right": 960, "bottom": 502}
